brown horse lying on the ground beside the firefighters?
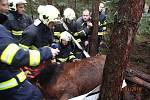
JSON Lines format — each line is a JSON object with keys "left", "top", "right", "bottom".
{"left": 38, "top": 55, "right": 106, "bottom": 100}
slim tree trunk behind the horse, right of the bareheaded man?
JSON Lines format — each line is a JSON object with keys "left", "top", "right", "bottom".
{"left": 90, "top": 0, "right": 99, "bottom": 56}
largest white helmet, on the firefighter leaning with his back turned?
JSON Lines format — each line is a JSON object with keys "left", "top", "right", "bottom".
{"left": 38, "top": 5, "right": 60, "bottom": 26}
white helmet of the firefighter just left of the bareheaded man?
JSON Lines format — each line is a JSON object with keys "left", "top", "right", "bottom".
{"left": 63, "top": 8, "right": 76, "bottom": 20}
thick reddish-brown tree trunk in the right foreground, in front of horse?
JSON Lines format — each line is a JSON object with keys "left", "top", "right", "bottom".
{"left": 99, "top": 0, "right": 145, "bottom": 100}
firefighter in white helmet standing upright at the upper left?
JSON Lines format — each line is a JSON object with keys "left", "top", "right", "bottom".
{"left": 5, "top": 0, "right": 32, "bottom": 42}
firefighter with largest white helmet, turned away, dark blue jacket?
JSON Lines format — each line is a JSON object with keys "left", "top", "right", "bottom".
{"left": 20, "top": 5, "right": 60, "bottom": 49}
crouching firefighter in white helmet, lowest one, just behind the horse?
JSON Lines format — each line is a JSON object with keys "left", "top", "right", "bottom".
{"left": 52, "top": 31, "right": 78, "bottom": 63}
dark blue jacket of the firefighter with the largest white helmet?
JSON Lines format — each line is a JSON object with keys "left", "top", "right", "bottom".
{"left": 20, "top": 19, "right": 53, "bottom": 48}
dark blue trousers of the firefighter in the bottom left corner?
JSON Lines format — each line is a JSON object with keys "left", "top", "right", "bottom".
{"left": 0, "top": 80, "right": 43, "bottom": 100}
